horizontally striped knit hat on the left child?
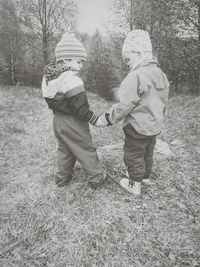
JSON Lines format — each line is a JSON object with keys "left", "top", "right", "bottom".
{"left": 55, "top": 33, "right": 87, "bottom": 62}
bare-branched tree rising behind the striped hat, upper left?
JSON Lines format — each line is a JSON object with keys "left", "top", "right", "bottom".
{"left": 20, "top": 0, "right": 76, "bottom": 65}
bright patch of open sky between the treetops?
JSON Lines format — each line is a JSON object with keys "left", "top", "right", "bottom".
{"left": 79, "top": 0, "right": 109, "bottom": 34}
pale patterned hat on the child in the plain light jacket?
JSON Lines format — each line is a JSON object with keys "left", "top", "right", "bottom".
{"left": 122, "top": 30, "right": 152, "bottom": 58}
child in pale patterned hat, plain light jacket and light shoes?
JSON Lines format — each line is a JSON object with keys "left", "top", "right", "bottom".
{"left": 98, "top": 30, "right": 169, "bottom": 194}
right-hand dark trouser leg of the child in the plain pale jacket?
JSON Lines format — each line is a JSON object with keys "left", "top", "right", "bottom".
{"left": 144, "top": 137, "right": 156, "bottom": 179}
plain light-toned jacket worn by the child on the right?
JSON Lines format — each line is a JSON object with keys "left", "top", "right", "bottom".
{"left": 106, "top": 60, "right": 169, "bottom": 136}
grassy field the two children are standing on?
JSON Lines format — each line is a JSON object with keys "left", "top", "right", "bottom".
{"left": 0, "top": 87, "right": 200, "bottom": 267}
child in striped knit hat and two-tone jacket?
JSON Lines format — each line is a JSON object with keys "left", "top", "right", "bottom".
{"left": 42, "top": 33, "right": 105, "bottom": 189}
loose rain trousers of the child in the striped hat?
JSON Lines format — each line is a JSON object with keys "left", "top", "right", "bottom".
{"left": 53, "top": 113, "right": 104, "bottom": 184}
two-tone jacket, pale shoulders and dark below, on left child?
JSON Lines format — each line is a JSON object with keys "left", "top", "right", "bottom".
{"left": 42, "top": 71, "right": 98, "bottom": 125}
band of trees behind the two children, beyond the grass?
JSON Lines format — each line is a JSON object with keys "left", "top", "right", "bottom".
{"left": 0, "top": 0, "right": 200, "bottom": 99}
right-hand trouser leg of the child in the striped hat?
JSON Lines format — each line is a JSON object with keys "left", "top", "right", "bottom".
{"left": 53, "top": 115, "right": 105, "bottom": 188}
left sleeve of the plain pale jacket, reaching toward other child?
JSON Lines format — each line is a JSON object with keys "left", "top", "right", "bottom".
{"left": 105, "top": 73, "right": 140, "bottom": 124}
